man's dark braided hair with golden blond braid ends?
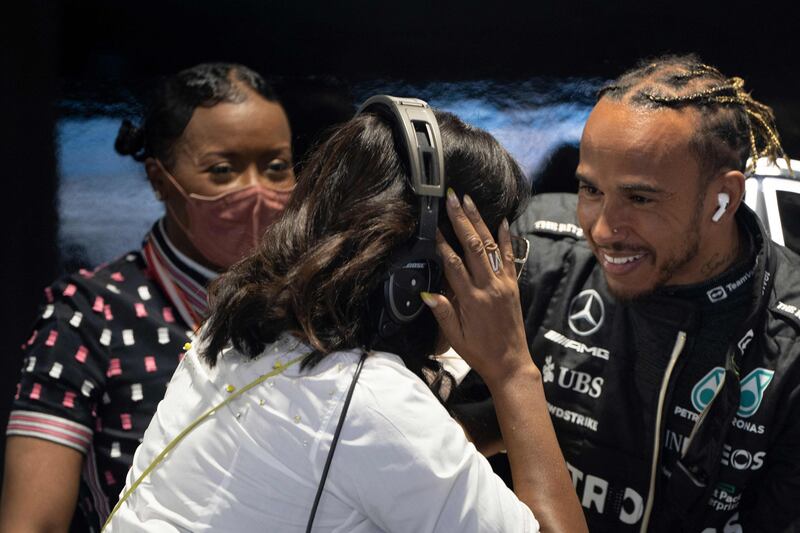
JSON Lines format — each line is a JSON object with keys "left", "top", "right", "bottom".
{"left": 598, "top": 55, "right": 791, "bottom": 179}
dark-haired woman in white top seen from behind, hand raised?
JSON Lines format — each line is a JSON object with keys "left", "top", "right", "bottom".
{"left": 108, "top": 105, "right": 585, "bottom": 533}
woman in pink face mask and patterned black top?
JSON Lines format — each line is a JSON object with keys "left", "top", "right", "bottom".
{"left": 0, "top": 64, "right": 295, "bottom": 532}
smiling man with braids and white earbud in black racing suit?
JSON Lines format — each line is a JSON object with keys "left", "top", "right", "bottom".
{"left": 456, "top": 56, "right": 800, "bottom": 533}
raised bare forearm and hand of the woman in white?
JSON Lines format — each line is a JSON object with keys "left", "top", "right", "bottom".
{"left": 423, "top": 190, "right": 587, "bottom": 533}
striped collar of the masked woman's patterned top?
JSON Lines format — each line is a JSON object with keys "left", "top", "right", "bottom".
{"left": 142, "top": 218, "right": 218, "bottom": 329}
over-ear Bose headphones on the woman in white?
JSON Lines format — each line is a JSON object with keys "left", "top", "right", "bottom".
{"left": 356, "top": 94, "right": 445, "bottom": 338}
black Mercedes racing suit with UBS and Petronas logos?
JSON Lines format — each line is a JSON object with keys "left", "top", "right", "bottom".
{"left": 500, "top": 194, "right": 800, "bottom": 533}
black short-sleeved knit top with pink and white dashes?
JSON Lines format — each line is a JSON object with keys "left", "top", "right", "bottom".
{"left": 7, "top": 221, "right": 214, "bottom": 531}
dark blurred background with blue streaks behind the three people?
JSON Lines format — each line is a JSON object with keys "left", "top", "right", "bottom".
{"left": 0, "top": 0, "right": 800, "bottom": 482}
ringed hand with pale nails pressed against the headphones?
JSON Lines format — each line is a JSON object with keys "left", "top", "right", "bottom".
{"left": 422, "top": 189, "right": 538, "bottom": 388}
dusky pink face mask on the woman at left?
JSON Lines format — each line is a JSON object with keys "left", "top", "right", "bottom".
{"left": 159, "top": 167, "right": 292, "bottom": 269}
